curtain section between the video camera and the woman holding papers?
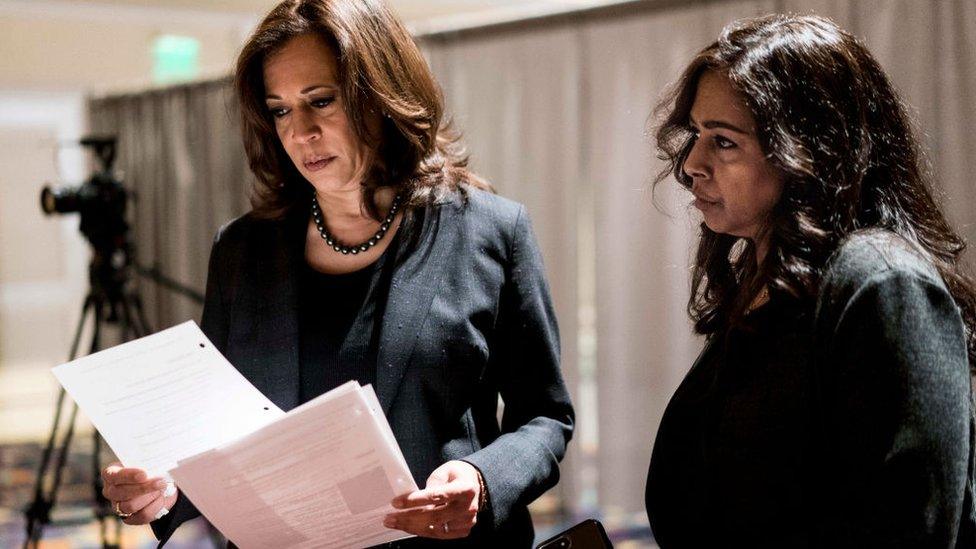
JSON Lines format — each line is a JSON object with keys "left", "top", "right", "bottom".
{"left": 89, "top": 80, "right": 251, "bottom": 330}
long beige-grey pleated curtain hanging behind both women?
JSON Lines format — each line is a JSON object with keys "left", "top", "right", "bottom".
{"left": 91, "top": 0, "right": 976, "bottom": 532}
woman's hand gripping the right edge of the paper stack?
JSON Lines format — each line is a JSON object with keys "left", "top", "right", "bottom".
{"left": 383, "top": 461, "right": 481, "bottom": 539}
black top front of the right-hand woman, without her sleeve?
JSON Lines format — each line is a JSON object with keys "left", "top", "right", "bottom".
{"left": 647, "top": 302, "right": 813, "bottom": 547}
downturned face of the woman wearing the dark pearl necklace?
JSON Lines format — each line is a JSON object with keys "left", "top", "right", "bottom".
{"left": 264, "top": 34, "right": 379, "bottom": 194}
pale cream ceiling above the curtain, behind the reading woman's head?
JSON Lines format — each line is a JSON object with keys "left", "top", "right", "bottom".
{"left": 0, "top": 0, "right": 621, "bottom": 93}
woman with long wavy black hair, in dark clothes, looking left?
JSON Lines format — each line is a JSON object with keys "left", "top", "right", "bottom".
{"left": 646, "top": 15, "right": 976, "bottom": 548}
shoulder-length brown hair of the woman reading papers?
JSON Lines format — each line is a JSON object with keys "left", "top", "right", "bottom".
{"left": 234, "top": 0, "right": 491, "bottom": 218}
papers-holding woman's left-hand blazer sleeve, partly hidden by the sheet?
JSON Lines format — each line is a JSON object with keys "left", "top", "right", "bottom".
{"left": 150, "top": 230, "right": 227, "bottom": 547}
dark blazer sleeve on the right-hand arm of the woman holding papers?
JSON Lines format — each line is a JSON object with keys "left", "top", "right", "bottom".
{"left": 464, "top": 207, "right": 574, "bottom": 528}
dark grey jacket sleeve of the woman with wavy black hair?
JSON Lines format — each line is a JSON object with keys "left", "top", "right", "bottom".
{"left": 817, "top": 268, "right": 972, "bottom": 547}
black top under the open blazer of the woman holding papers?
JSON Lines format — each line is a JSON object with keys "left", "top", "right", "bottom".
{"left": 298, "top": 262, "right": 377, "bottom": 402}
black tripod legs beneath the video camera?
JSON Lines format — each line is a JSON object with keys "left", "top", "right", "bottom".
{"left": 24, "top": 253, "right": 150, "bottom": 549}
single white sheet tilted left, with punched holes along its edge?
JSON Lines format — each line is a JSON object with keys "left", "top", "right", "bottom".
{"left": 53, "top": 321, "right": 284, "bottom": 476}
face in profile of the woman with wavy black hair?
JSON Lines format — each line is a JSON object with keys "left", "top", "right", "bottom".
{"left": 683, "top": 71, "right": 783, "bottom": 239}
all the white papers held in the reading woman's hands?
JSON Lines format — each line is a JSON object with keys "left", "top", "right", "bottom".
{"left": 54, "top": 321, "right": 417, "bottom": 549}
